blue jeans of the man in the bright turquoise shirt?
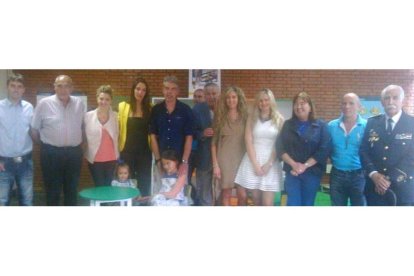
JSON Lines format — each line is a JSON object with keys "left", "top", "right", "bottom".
{"left": 329, "top": 167, "right": 366, "bottom": 206}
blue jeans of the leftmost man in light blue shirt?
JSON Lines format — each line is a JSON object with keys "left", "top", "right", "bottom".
{"left": 0, "top": 159, "right": 33, "bottom": 206}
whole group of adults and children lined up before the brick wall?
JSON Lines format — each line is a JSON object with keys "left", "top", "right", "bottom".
{"left": 0, "top": 74, "right": 414, "bottom": 206}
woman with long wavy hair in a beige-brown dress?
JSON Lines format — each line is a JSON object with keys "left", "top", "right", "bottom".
{"left": 211, "top": 86, "right": 247, "bottom": 206}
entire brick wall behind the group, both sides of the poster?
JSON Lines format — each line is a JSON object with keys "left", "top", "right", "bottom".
{"left": 14, "top": 70, "right": 414, "bottom": 189}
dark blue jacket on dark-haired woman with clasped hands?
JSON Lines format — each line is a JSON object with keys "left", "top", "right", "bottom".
{"left": 276, "top": 118, "right": 331, "bottom": 176}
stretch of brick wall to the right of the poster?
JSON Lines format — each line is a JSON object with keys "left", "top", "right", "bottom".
{"left": 222, "top": 70, "right": 414, "bottom": 120}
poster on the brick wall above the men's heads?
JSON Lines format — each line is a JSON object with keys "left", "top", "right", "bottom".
{"left": 188, "top": 69, "right": 220, "bottom": 98}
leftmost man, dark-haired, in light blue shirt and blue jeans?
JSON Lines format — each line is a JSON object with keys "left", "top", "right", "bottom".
{"left": 0, "top": 74, "right": 33, "bottom": 206}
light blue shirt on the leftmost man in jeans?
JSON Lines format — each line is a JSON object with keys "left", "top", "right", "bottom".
{"left": 0, "top": 98, "right": 33, "bottom": 157}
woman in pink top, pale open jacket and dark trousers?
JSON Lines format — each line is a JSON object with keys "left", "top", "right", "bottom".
{"left": 84, "top": 85, "right": 119, "bottom": 186}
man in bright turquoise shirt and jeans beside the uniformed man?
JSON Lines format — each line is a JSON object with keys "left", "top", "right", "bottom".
{"left": 328, "top": 93, "right": 367, "bottom": 206}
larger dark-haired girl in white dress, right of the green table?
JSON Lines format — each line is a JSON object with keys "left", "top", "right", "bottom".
{"left": 151, "top": 150, "right": 188, "bottom": 206}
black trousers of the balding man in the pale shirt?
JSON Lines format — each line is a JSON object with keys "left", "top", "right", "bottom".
{"left": 40, "top": 144, "right": 82, "bottom": 206}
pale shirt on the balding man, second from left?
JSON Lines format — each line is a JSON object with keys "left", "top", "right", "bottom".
{"left": 32, "top": 95, "right": 85, "bottom": 147}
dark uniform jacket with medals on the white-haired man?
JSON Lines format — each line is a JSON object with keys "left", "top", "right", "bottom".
{"left": 360, "top": 112, "right": 414, "bottom": 204}
